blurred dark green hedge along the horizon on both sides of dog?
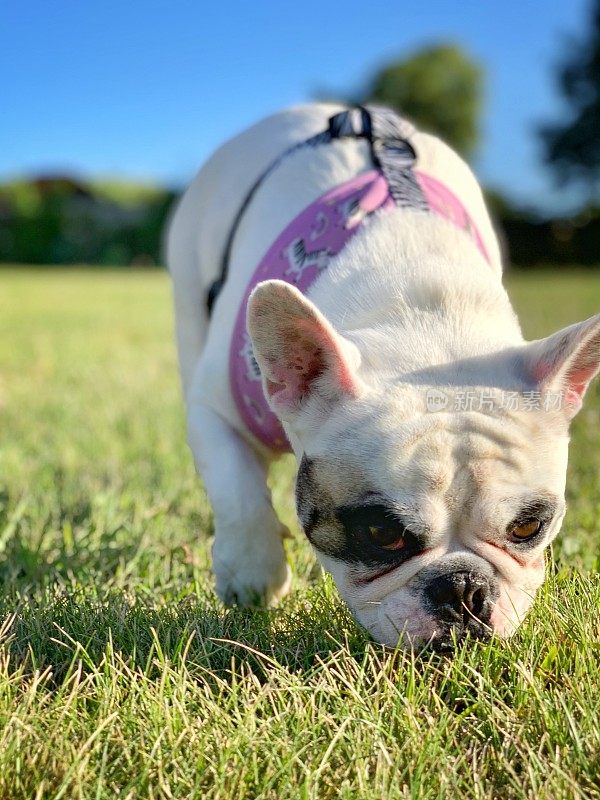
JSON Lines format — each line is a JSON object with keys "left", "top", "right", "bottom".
{"left": 0, "top": 176, "right": 600, "bottom": 267}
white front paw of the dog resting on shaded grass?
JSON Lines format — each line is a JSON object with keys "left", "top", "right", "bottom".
{"left": 212, "top": 534, "right": 291, "bottom": 606}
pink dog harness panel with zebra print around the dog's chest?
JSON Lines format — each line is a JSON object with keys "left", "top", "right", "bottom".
{"left": 229, "top": 170, "right": 490, "bottom": 452}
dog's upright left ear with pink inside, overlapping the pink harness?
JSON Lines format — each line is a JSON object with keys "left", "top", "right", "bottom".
{"left": 246, "top": 280, "right": 361, "bottom": 421}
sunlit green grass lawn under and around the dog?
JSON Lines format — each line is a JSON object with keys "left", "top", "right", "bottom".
{"left": 0, "top": 270, "right": 600, "bottom": 800}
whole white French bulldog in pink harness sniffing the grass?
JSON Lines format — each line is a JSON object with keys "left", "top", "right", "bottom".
{"left": 168, "top": 105, "right": 600, "bottom": 647}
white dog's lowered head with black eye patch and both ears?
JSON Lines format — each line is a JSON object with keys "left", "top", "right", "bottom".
{"left": 248, "top": 281, "right": 600, "bottom": 647}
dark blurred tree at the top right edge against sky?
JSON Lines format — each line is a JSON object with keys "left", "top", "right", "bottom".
{"left": 539, "top": 0, "right": 600, "bottom": 199}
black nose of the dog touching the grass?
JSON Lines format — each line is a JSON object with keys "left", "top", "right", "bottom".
{"left": 425, "top": 571, "right": 495, "bottom": 628}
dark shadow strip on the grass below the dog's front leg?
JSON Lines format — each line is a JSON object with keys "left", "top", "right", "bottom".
{"left": 0, "top": 587, "right": 369, "bottom": 682}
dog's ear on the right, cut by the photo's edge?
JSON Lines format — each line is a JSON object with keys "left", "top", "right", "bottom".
{"left": 525, "top": 314, "right": 600, "bottom": 419}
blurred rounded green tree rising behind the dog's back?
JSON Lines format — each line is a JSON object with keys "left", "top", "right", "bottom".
{"left": 362, "top": 44, "right": 483, "bottom": 155}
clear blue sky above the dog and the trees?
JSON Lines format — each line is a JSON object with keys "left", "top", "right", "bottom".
{"left": 0, "top": 0, "right": 589, "bottom": 208}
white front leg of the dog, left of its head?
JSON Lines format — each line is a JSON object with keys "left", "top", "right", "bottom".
{"left": 188, "top": 404, "right": 290, "bottom": 605}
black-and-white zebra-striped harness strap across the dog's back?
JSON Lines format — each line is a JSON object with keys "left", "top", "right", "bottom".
{"left": 206, "top": 106, "right": 422, "bottom": 314}
